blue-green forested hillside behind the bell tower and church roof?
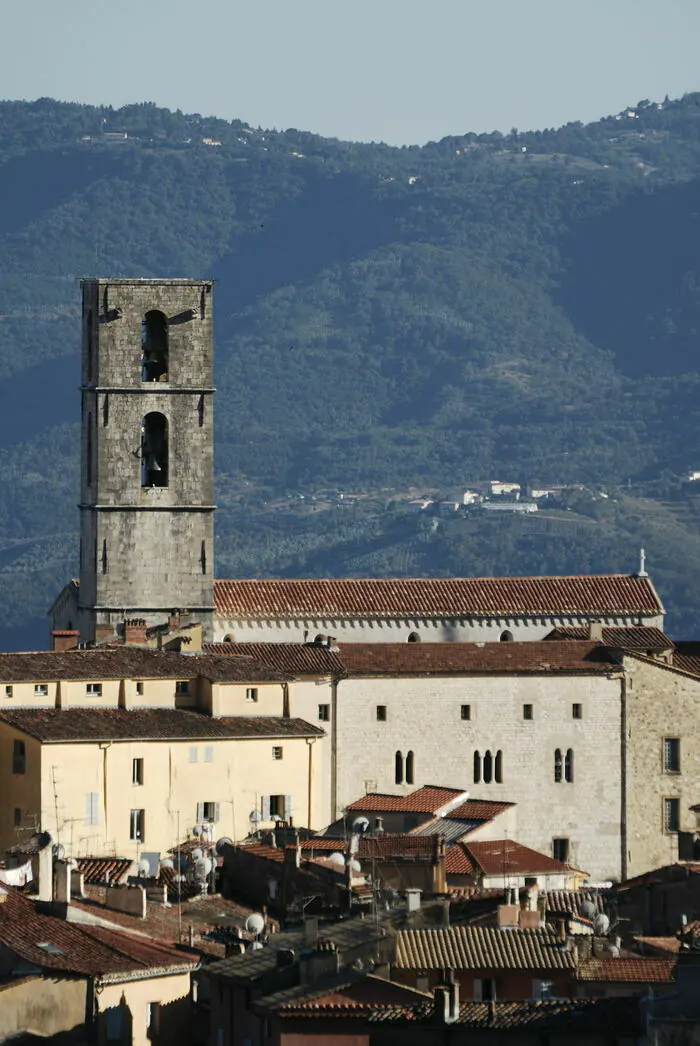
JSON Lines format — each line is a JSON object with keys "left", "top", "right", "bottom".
{"left": 0, "top": 94, "right": 700, "bottom": 647}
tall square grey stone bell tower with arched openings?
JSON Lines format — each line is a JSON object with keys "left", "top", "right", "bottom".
{"left": 77, "top": 279, "right": 214, "bottom": 642}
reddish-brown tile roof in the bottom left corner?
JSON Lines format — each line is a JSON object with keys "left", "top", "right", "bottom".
{"left": 0, "top": 888, "right": 198, "bottom": 977}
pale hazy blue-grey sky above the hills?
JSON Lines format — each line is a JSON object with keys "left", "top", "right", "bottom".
{"left": 0, "top": 0, "right": 700, "bottom": 144}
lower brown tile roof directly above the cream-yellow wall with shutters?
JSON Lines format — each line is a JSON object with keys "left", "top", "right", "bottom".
{"left": 0, "top": 708, "right": 323, "bottom": 743}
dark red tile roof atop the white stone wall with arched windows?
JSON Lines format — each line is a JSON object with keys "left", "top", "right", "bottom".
{"left": 338, "top": 640, "right": 616, "bottom": 676}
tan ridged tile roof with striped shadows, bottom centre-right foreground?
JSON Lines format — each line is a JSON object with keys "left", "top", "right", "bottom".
{"left": 396, "top": 926, "right": 577, "bottom": 972}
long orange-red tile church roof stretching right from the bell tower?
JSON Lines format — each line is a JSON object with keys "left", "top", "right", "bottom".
{"left": 213, "top": 574, "right": 663, "bottom": 620}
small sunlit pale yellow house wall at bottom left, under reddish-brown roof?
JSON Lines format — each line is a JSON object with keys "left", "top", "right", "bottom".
{"left": 95, "top": 973, "right": 191, "bottom": 1046}
